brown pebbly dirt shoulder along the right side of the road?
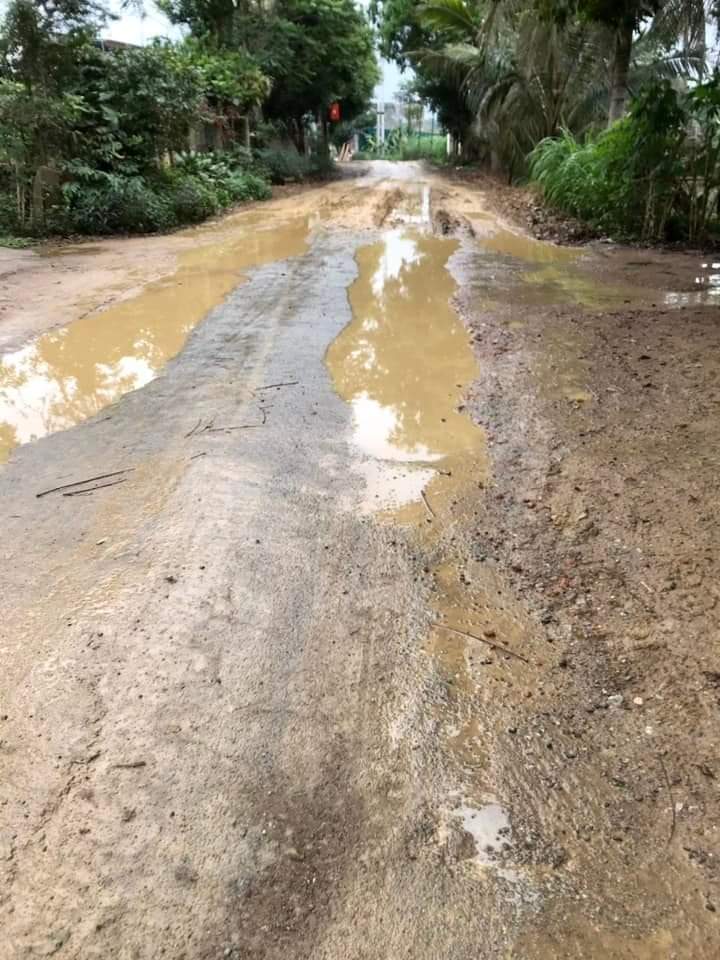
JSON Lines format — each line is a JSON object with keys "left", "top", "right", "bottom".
{"left": 464, "top": 284, "right": 720, "bottom": 958}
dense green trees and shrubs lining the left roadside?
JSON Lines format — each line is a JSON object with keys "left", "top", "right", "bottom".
{"left": 0, "top": 0, "right": 377, "bottom": 240}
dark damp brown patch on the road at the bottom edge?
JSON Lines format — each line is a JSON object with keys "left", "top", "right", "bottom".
{"left": 204, "top": 743, "right": 370, "bottom": 960}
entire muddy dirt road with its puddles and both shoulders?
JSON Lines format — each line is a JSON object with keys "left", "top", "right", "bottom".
{"left": 0, "top": 164, "right": 720, "bottom": 960}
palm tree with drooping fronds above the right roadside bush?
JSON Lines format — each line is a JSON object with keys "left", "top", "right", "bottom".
{"left": 414, "top": 0, "right": 713, "bottom": 175}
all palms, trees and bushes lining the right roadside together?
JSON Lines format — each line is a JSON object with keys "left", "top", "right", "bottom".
{"left": 371, "top": 0, "right": 720, "bottom": 243}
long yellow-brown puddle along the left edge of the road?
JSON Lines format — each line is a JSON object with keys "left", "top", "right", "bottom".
{"left": 0, "top": 218, "right": 312, "bottom": 463}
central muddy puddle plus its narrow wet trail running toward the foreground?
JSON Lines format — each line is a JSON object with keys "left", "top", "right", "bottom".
{"left": 326, "top": 202, "right": 538, "bottom": 936}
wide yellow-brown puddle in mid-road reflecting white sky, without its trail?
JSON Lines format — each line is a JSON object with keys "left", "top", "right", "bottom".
{"left": 326, "top": 228, "right": 482, "bottom": 509}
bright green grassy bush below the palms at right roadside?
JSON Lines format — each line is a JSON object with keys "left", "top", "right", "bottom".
{"left": 529, "top": 74, "right": 720, "bottom": 242}
